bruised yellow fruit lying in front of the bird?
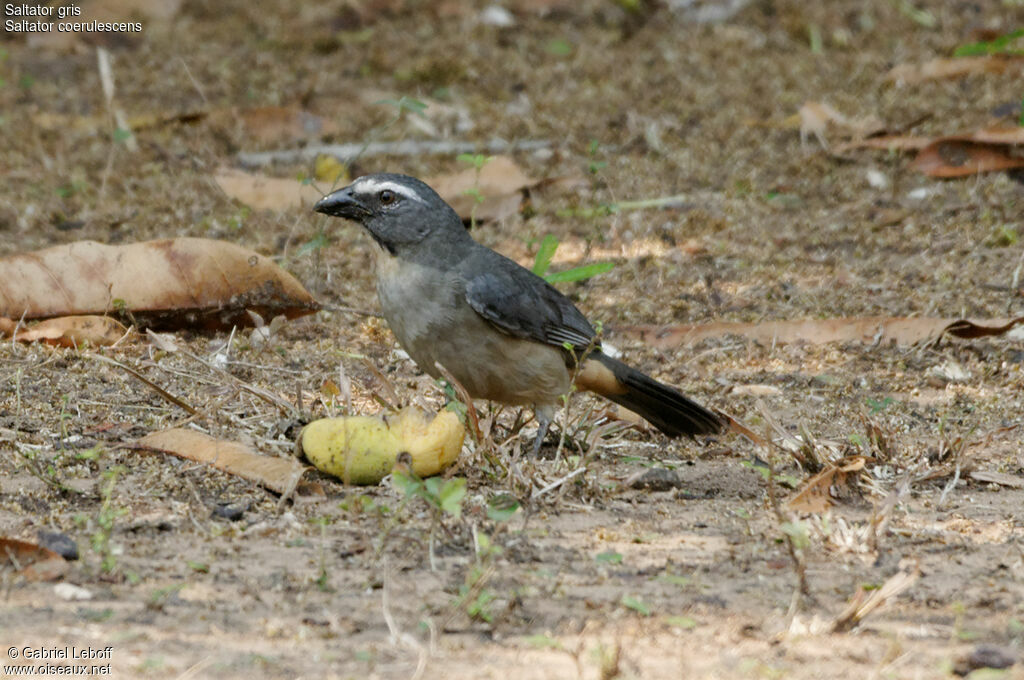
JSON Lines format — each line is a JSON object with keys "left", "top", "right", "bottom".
{"left": 299, "top": 407, "right": 466, "bottom": 484}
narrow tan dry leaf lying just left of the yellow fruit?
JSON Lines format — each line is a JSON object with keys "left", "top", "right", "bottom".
{"left": 134, "top": 427, "right": 308, "bottom": 495}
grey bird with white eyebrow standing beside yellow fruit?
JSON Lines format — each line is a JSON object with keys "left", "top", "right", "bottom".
{"left": 313, "top": 173, "right": 725, "bottom": 455}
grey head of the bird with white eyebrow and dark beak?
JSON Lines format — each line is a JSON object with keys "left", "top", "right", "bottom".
{"left": 313, "top": 173, "right": 466, "bottom": 255}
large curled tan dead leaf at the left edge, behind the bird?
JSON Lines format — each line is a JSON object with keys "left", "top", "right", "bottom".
{"left": 0, "top": 239, "right": 318, "bottom": 329}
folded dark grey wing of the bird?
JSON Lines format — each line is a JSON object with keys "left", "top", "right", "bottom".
{"left": 463, "top": 250, "right": 600, "bottom": 350}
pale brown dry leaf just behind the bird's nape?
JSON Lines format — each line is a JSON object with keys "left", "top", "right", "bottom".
{"left": 424, "top": 156, "right": 538, "bottom": 221}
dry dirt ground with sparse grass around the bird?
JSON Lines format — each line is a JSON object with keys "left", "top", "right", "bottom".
{"left": 0, "top": 0, "right": 1024, "bottom": 680}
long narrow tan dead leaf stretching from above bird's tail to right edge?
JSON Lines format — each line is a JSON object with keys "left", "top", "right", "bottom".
{"left": 614, "top": 316, "right": 1024, "bottom": 349}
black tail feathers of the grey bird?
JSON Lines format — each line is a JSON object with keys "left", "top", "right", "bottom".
{"left": 590, "top": 351, "right": 725, "bottom": 437}
